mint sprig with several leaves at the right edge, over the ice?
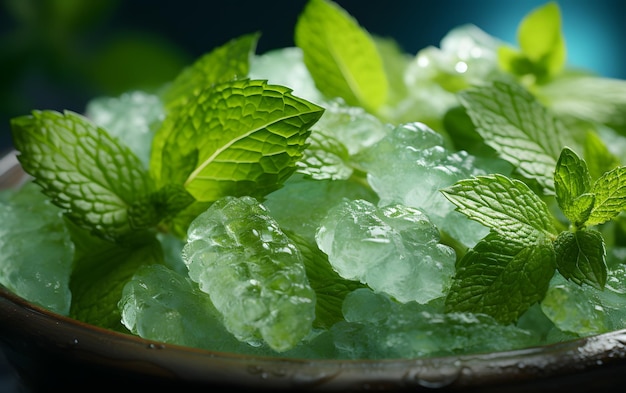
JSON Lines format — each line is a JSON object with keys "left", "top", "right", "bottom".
{"left": 442, "top": 147, "right": 626, "bottom": 323}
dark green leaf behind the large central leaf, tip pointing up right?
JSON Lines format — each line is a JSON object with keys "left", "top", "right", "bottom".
{"left": 162, "top": 33, "right": 260, "bottom": 109}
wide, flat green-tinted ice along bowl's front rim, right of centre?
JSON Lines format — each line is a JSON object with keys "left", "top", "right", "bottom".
{"left": 301, "top": 288, "right": 540, "bottom": 359}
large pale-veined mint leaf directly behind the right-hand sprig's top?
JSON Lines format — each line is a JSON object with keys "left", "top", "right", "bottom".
{"left": 459, "top": 81, "right": 574, "bottom": 193}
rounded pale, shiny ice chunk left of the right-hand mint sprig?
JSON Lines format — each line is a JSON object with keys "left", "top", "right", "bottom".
{"left": 316, "top": 200, "right": 456, "bottom": 303}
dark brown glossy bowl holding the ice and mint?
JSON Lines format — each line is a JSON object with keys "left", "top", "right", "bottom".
{"left": 0, "top": 149, "right": 626, "bottom": 393}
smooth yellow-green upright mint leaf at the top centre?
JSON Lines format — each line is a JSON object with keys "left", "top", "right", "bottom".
{"left": 294, "top": 0, "right": 389, "bottom": 112}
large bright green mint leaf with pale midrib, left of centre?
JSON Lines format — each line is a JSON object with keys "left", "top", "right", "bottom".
{"left": 158, "top": 79, "right": 324, "bottom": 202}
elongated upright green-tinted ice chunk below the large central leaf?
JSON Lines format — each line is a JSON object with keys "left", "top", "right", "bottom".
{"left": 183, "top": 196, "right": 315, "bottom": 352}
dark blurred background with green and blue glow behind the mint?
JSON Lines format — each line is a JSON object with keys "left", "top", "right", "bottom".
{"left": 0, "top": 0, "right": 626, "bottom": 154}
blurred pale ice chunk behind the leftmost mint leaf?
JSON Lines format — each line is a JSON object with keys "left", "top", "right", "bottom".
{"left": 85, "top": 90, "right": 165, "bottom": 168}
